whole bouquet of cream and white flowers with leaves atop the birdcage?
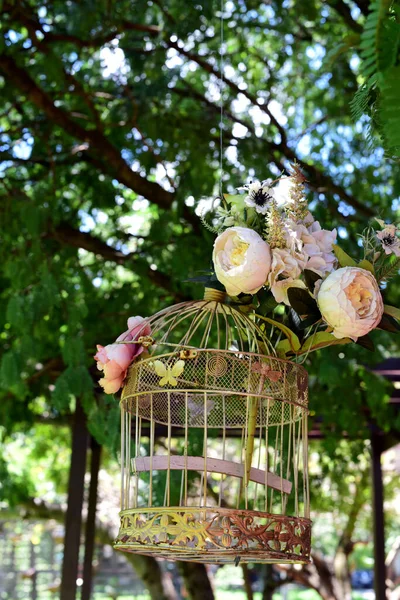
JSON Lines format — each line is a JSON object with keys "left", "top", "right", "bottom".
{"left": 208, "top": 165, "right": 400, "bottom": 357}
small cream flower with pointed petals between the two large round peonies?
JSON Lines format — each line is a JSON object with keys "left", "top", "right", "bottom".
{"left": 268, "top": 248, "right": 306, "bottom": 306}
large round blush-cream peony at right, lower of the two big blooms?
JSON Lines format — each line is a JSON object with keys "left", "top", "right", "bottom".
{"left": 317, "top": 267, "right": 383, "bottom": 342}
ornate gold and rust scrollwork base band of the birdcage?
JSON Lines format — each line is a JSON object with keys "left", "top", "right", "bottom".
{"left": 114, "top": 506, "right": 311, "bottom": 564}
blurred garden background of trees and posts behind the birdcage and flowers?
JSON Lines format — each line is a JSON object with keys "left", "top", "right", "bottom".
{"left": 0, "top": 0, "right": 400, "bottom": 600}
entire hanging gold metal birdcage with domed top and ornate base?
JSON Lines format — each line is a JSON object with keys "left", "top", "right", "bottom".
{"left": 115, "top": 289, "right": 311, "bottom": 564}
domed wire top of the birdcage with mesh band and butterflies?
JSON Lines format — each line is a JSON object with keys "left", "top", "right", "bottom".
{"left": 121, "top": 290, "right": 307, "bottom": 428}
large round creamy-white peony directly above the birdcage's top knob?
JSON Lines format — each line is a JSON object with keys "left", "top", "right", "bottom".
{"left": 213, "top": 227, "right": 271, "bottom": 296}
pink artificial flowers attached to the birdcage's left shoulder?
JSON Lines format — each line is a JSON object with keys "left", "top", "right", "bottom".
{"left": 94, "top": 317, "right": 151, "bottom": 394}
